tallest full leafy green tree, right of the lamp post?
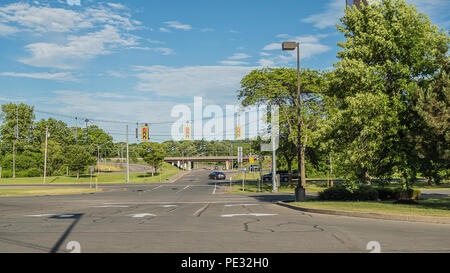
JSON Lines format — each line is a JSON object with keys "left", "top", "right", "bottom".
{"left": 328, "top": 0, "right": 450, "bottom": 188}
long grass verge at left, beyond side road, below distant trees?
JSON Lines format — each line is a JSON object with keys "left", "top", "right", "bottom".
{"left": 0, "top": 164, "right": 182, "bottom": 185}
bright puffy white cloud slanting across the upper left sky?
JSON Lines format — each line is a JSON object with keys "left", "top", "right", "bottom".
{"left": 19, "top": 25, "right": 137, "bottom": 69}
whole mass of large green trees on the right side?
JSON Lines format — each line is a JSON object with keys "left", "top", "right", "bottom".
{"left": 238, "top": 0, "right": 450, "bottom": 188}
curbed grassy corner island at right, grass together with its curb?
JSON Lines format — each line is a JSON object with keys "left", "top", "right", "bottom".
{"left": 277, "top": 201, "right": 450, "bottom": 224}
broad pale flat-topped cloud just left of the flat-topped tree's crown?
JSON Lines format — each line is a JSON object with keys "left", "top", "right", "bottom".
{"left": 135, "top": 66, "right": 257, "bottom": 100}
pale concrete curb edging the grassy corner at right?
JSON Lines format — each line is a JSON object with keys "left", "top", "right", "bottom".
{"left": 276, "top": 201, "right": 450, "bottom": 224}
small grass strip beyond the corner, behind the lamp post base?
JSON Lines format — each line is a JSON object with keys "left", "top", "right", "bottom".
{"left": 229, "top": 182, "right": 327, "bottom": 193}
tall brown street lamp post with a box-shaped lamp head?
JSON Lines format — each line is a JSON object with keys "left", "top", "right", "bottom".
{"left": 282, "top": 42, "right": 306, "bottom": 202}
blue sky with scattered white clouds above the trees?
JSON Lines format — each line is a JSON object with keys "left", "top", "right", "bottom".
{"left": 0, "top": 0, "right": 450, "bottom": 140}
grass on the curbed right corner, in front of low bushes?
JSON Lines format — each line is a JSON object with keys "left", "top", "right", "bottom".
{"left": 291, "top": 197, "right": 450, "bottom": 217}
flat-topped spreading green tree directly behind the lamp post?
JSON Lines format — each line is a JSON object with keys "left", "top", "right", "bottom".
{"left": 238, "top": 68, "right": 325, "bottom": 187}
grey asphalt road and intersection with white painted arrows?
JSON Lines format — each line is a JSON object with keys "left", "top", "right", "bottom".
{"left": 0, "top": 170, "right": 450, "bottom": 253}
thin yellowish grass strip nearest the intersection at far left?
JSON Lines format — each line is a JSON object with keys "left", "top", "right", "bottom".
{"left": 0, "top": 188, "right": 102, "bottom": 197}
